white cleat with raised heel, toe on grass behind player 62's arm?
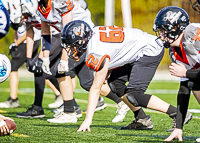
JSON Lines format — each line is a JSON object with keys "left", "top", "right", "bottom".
{"left": 112, "top": 101, "right": 130, "bottom": 123}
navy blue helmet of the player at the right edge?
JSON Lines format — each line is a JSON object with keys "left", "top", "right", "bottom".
{"left": 153, "top": 6, "right": 190, "bottom": 48}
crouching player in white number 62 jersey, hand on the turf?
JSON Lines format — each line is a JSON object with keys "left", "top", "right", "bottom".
{"left": 61, "top": 20, "right": 189, "bottom": 131}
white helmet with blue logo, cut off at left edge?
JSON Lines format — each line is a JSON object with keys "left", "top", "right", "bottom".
{"left": 0, "top": 54, "right": 11, "bottom": 83}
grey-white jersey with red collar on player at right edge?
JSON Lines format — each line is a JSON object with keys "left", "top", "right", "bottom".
{"left": 170, "top": 23, "right": 200, "bottom": 81}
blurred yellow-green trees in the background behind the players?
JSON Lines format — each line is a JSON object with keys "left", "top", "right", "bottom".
{"left": 0, "top": 0, "right": 200, "bottom": 70}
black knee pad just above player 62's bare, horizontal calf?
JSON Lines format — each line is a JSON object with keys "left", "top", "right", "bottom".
{"left": 126, "top": 89, "right": 151, "bottom": 108}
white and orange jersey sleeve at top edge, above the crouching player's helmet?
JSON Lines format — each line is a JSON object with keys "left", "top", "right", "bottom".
{"left": 52, "top": 0, "right": 74, "bottom": 16}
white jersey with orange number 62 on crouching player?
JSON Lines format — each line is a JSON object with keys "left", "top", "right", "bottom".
{"left": 86, "top": 26, "right": 163, "bottom": 71}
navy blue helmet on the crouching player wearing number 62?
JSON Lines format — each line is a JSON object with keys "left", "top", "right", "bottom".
{"left": 61, "top": 20, "right": 92, "bottom": 61}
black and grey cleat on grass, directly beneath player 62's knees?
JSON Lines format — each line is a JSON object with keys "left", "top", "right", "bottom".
{"left": 120, "top": 115, "right": 153, "bottom": 130}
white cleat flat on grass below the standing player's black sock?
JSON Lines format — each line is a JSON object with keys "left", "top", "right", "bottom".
{"left": 47, "top": 112, "right": 77, "bottom": 123}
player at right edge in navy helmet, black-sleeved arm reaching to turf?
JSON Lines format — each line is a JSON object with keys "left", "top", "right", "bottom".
{"left": 153, "top": 6, "right": 197, "bottom": 141}
